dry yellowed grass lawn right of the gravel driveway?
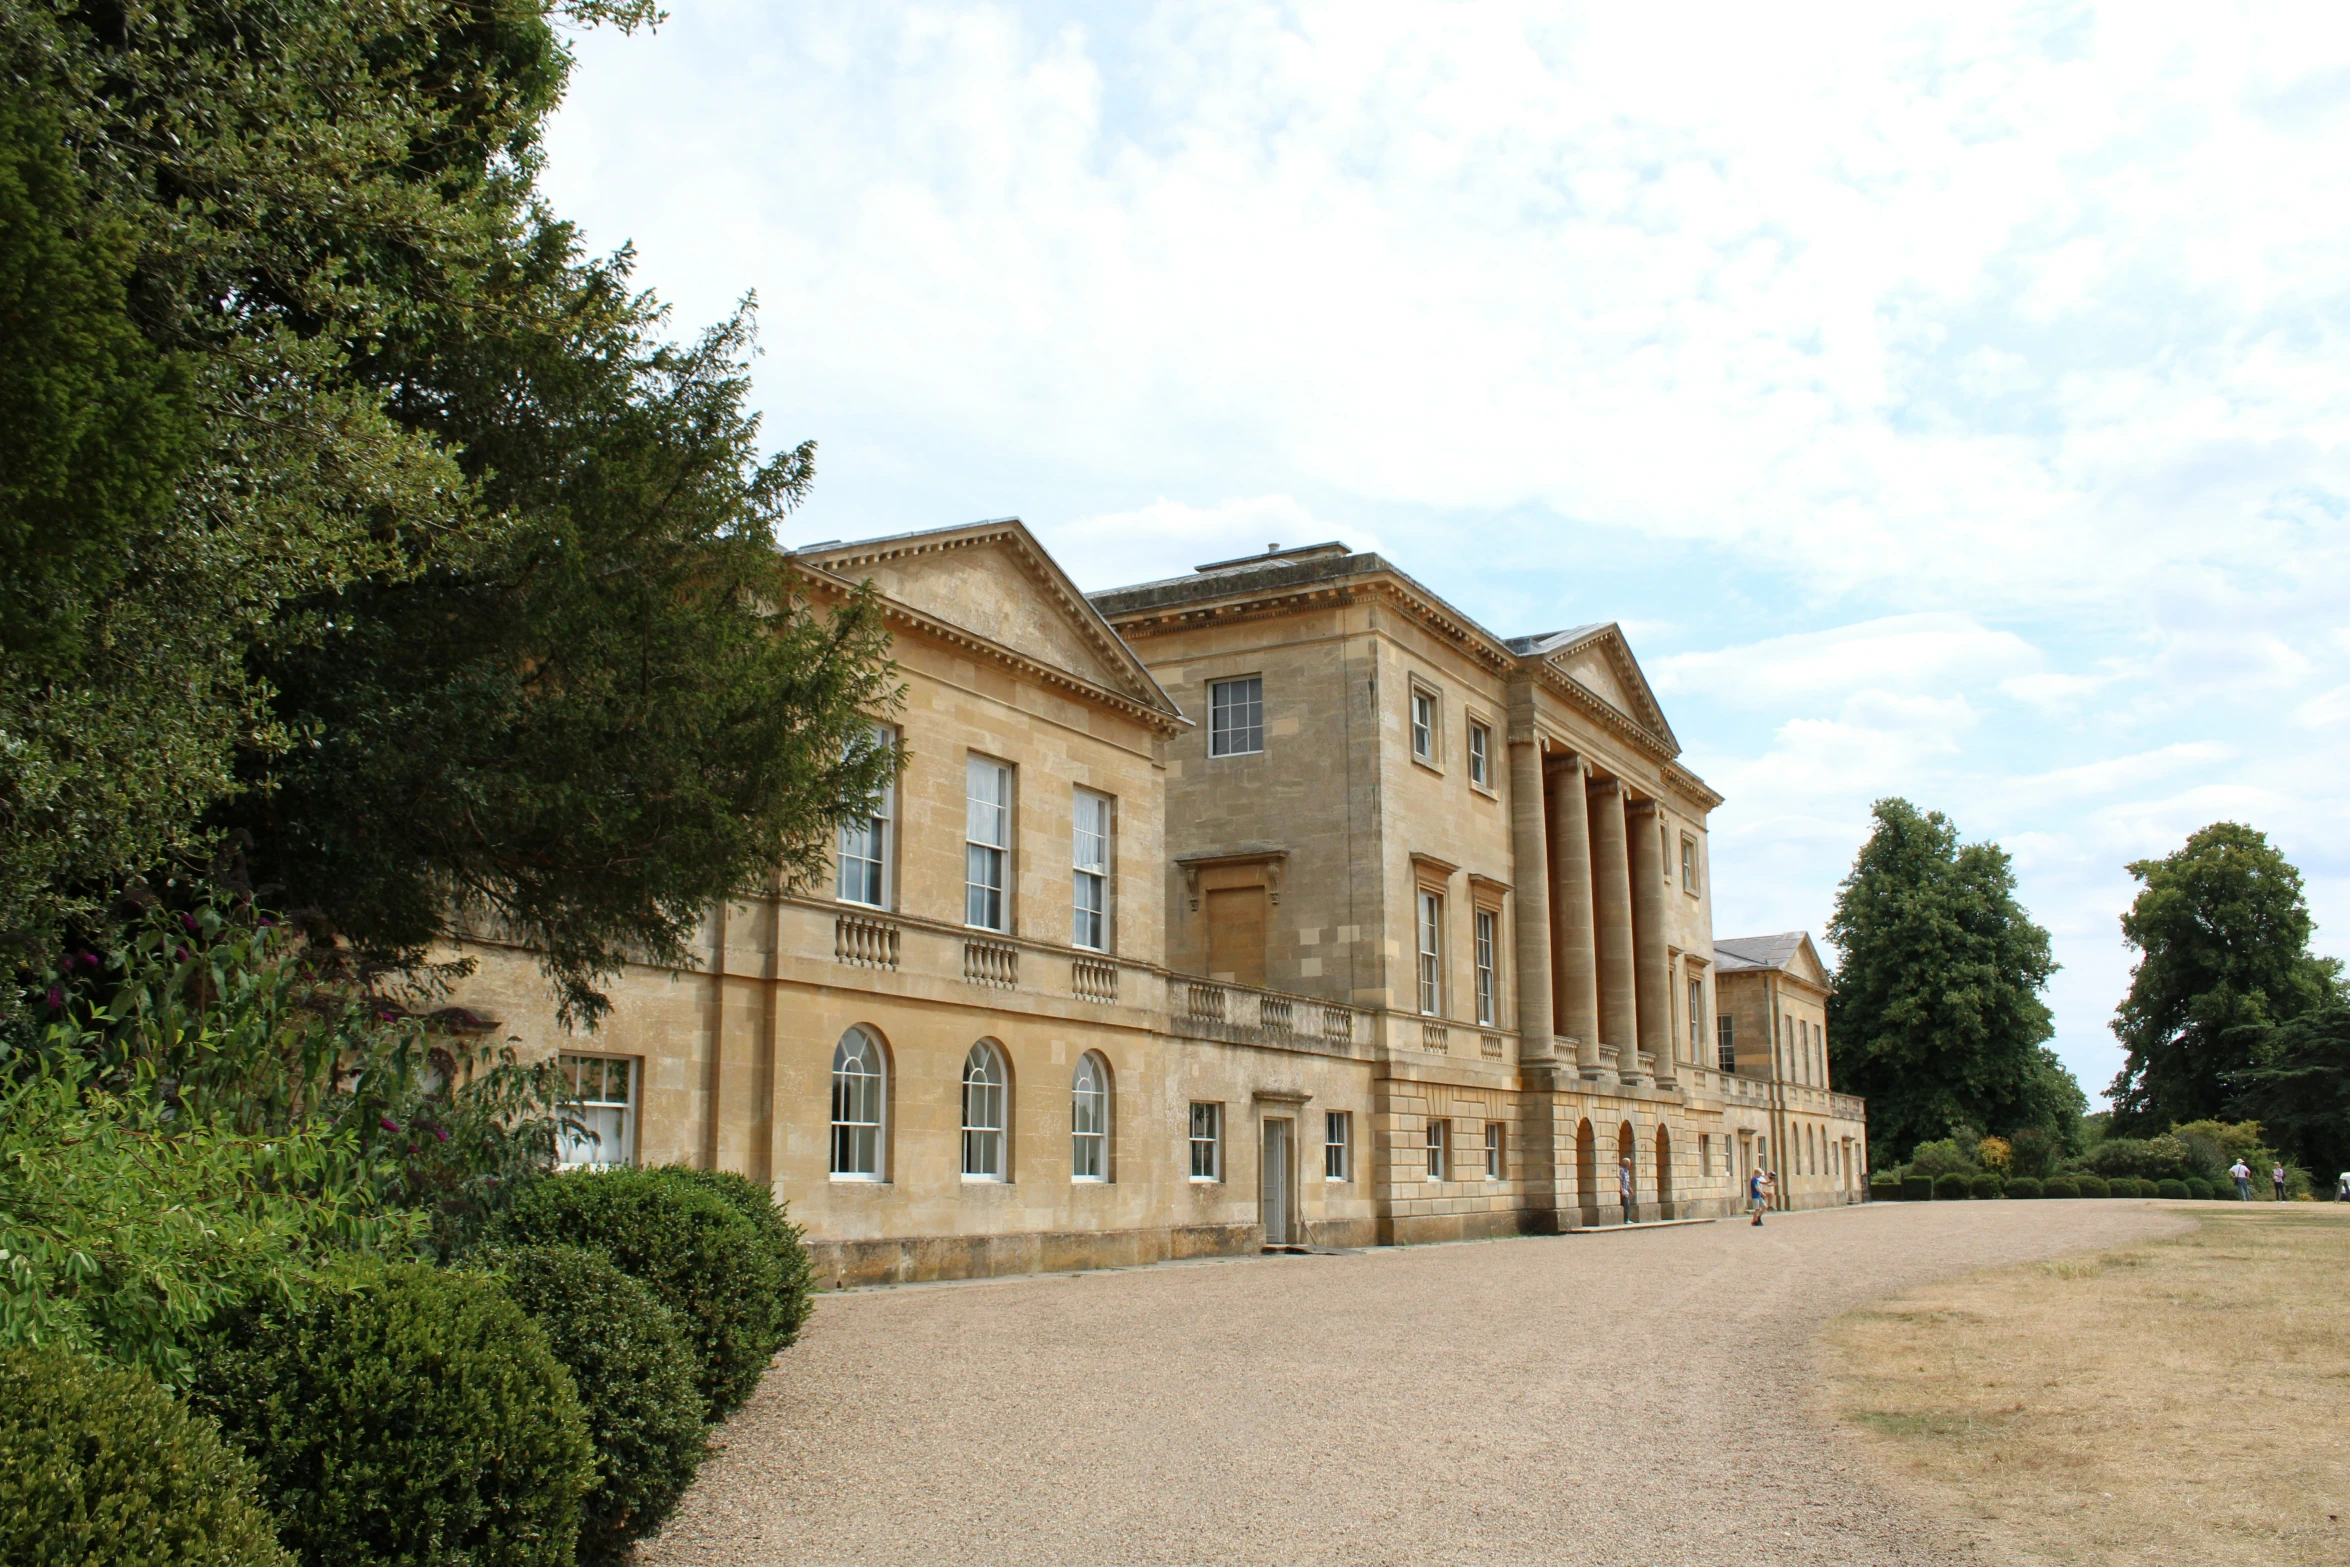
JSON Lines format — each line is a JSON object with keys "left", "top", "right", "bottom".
{"left": 1821, "top": 1203, "right": 2350, "bottom": 1567}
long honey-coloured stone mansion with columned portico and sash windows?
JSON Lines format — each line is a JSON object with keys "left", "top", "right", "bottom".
{"left": 444, "top": 519, "right": 1868, "bottom": 1285}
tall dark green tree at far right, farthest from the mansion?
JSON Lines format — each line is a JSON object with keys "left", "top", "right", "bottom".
{"left": 2110, "top": 822, "right": 2338, "bottom": 1137}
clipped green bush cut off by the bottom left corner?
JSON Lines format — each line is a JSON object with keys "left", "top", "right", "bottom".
{"left": 0, "top": 1349, "right": 294, "bottom": 1567}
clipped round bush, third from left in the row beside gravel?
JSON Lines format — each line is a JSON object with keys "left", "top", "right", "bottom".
{"left": 496, "top": 1245, "right": 710, "bottom": 1565}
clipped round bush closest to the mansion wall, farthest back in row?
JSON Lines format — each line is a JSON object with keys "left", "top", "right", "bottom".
{"left": 505, "top": 1165, "right": 783, "bottom": 1419}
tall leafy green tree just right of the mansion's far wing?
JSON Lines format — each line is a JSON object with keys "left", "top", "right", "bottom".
{"left": 1828, "top": 799, "right": 2082, "bottom": 1165}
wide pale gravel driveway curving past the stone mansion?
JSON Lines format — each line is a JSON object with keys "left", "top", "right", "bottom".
{"left": 642, "top": 1201, "right": 2181, "bottom": 1567}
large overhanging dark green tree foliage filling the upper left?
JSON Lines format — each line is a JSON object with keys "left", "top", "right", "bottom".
{"left": 0, "top": 0, "right": 895, "bottom": 1015}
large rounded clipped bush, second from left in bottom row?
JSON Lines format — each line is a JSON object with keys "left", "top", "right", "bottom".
{"left": 188, "top": 1262, "right": 595, "bottom": 1567}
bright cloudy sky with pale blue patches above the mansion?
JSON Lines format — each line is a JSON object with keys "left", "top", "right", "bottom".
{"left": 548, "top": 0, "right": 2350, "bottom": 1097}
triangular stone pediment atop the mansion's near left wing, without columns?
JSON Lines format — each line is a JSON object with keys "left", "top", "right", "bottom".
{"left": 794, "top": 517, "right": 1177, "bottom": 714}
